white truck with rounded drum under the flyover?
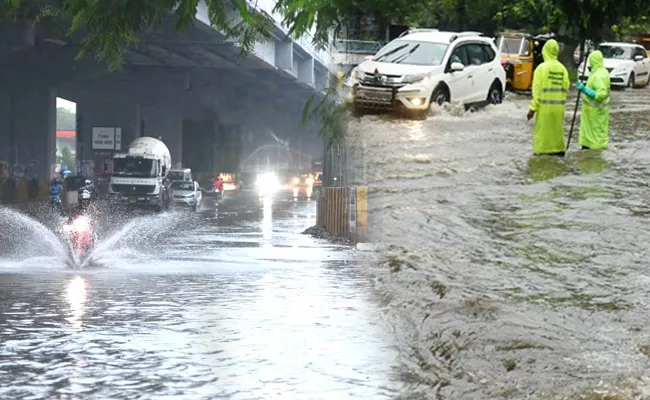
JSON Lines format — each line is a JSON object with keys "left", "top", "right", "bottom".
{"left": 109, "top": 137, "right": 171, "bottom": 211}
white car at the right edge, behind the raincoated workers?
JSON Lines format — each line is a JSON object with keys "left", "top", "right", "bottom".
{"left": 578, "top": 42, "right": 650, "bottom": 87}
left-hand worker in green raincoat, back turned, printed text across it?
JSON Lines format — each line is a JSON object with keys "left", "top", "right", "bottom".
{"left": 528, "top": 39, "right": 570, "bottom": 156}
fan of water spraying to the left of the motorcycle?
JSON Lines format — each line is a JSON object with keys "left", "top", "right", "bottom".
{"left": 0, "top": 208, "right": 68, "bottom": 259}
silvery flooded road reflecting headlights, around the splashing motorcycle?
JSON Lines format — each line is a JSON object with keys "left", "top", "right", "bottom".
{"left": 0, "top": 196, "right": 398, "bottom": 399}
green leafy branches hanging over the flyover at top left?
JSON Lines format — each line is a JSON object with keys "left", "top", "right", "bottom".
{"left": 0, "top": 0, "right": 273, "bottom": 69}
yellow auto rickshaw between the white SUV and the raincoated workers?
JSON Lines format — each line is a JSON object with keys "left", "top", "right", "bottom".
{"left": 496, "top": 32, "right": 552, "bottom": 91}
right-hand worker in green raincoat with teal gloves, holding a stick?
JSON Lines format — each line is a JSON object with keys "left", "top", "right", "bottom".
{"left": 576, "top": 50, "right": 611, "bottom": 150}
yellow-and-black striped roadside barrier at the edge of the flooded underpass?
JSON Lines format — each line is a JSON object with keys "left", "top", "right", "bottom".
{"left": 316, "top": 186, "right": 368, "bottom": 243}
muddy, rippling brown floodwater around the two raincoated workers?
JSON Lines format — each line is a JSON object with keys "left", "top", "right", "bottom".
{"left": 351, "top": 88, "right": 650, "bottom": 400}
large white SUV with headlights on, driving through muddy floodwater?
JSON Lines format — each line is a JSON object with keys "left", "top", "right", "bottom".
{"left": 345, "top": 29, "right": 506, "bottom": 118}
